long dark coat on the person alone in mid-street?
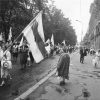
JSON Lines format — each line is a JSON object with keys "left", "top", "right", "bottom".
{"left": 57, "top": 53, "right": 70, "bottom": 79}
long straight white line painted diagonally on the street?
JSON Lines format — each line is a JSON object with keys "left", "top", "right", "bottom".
{"left": 14, "top": 68, "right": 57, "bottom": 100}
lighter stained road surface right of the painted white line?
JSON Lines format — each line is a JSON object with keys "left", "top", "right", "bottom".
{"left": 26, "top": 53, "right": 100, "bottom": 100}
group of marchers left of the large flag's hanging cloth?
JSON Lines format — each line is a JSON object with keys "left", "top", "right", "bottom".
{"left": 0, "top": 42, "right": 34, "bottom": 86}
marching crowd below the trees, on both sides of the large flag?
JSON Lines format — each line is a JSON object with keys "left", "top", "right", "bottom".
{"left": 0, "top": 42, "right": 75, "bottom": 86}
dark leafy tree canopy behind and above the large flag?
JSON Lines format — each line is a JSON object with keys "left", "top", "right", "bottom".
{"left": 0, "top": 0, "right": 77, "bottom": 45}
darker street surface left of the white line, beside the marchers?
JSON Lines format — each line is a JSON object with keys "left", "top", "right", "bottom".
{"left": 0, "top": 56, "right": 59, "bottom": 100}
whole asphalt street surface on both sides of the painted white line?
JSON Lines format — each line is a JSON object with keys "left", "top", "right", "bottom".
{"left": 0, "top": 52, "right": 100, "bottom": 100}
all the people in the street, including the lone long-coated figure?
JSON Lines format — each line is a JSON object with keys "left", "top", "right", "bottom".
{"left": 0, "top": 42, "right": 100, "bottom": 86}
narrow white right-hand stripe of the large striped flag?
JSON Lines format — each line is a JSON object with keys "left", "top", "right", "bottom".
{"left": 36, "top": 12, "right": 45, "bottom": 42}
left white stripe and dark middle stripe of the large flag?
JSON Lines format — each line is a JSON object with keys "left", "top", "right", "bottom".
{"left": 22, "top": 12, "right": 46, "bottom": 63}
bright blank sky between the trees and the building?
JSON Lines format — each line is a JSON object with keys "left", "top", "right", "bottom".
{"left": 54, "top": 0, "right": 94, "bottom": 42}
